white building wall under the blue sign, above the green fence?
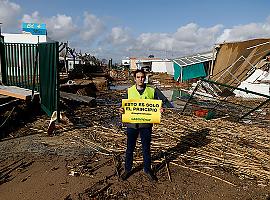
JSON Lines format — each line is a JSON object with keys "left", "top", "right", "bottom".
{"left": 2, "top": 33, "right": 47, "bottom": 44}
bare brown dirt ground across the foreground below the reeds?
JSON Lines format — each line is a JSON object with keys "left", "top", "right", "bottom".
{"left": 0, "top": 149, "right": 270, "bottom": 200}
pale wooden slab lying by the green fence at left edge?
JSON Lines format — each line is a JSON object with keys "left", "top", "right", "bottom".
{"left": 0, "top": 85, "right": 39, "bottom": 101}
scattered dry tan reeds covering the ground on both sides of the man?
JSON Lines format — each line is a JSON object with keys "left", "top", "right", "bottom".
{"left": 50, "top": 104, "right": 270, "bottom": 185}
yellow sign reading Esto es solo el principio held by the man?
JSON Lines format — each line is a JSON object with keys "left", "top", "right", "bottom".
{"left": 122, "top": 99, "right": 162, "bottom": 124}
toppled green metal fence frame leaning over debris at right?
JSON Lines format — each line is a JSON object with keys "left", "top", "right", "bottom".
{"left": 182, "top": 79, "right": 270, "bottom": 126}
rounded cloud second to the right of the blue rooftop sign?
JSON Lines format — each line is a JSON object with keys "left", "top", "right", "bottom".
{"left": 80, "top": 12, "right": 105, "bottom": 43}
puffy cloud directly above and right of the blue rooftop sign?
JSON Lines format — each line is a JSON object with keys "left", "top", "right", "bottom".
{"left": 22, "top": 11, "right": 77, "bottom": 41}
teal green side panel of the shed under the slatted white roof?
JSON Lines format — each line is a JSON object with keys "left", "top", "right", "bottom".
{"left": 182, "top": 63, "right": 206, "bottom": 81}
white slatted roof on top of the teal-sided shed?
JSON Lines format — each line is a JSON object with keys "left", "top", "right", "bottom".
{"left": 173, "top": 52, "right": 213, "bottom": 67}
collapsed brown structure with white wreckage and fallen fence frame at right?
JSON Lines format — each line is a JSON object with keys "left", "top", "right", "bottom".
{"left": 180, "top": 39, "right": 270, "bottom": 126}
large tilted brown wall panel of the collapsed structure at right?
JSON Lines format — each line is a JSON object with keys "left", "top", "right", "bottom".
{"left": 210, "top": 39, "right": 270, "bottom": 87}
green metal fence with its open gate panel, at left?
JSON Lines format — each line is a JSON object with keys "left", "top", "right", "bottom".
{"left": 0, "top": 42, "right": 59, "bottom": 116}
